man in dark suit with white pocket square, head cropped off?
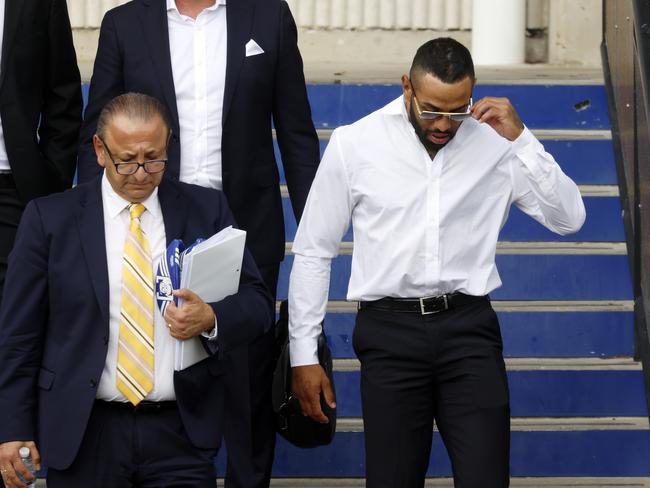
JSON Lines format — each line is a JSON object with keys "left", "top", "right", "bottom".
{"left": 79, "top": 0, "right": 320, "bottom": 488}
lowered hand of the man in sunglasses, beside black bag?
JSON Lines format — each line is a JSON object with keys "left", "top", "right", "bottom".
{"left": 291, "top": 364, "right": 336, "bottom": 424}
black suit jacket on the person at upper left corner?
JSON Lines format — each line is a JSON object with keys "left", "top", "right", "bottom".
{"left": 0, "top": 0, "right": 82, "bottom": 202}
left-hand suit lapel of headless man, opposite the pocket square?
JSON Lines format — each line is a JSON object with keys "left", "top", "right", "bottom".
{"left": 133, "top": 0, "right": 179, "bottom": 133}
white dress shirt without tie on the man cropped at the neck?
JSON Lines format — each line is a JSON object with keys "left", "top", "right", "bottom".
{"left": 167, "top": 0, "right": 228, "bottom": 190}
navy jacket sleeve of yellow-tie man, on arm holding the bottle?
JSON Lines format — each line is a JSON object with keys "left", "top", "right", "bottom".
{"left": 0, "top": 202, "right": 49, "bottom": 442}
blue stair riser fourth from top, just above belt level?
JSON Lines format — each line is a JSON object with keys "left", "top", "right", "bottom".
{"left": 278, "top": 254, "right": 632, "bottom": 300}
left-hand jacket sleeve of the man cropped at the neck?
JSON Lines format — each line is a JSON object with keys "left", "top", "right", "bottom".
{"left": 78, "top": 12, "right": 124, "bottom": 183}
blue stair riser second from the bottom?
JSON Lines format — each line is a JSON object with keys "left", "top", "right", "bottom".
{"left": 334, "top": 370, "right": 650, "bottom": 418}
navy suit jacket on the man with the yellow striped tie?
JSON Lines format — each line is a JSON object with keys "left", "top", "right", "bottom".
{"left": 0, "top": 178, "right": 273, "bottom": 469}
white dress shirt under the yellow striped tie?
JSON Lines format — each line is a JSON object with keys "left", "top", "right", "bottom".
{"left": 97, "top": 174, "right": 175, "bottom": 402}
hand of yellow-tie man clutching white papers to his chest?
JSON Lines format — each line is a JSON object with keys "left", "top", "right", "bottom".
{"left": 165, "top": 288, "right": 214, "bottom": 340}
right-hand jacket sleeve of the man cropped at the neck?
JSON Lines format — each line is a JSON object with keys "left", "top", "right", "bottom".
{"left": 273, "top": 1, "right": 320, "bottom": 222}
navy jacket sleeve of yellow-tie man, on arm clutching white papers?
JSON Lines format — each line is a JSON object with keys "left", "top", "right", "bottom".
{"left": 205, "top": 192, "right": 275, "bottom": 355}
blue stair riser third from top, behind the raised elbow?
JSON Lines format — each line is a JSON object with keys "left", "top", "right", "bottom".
{"left": 282, "top": 197, "right": 625, "bottom": 242}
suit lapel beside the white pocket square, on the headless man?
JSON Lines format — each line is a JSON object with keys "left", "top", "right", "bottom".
{"left": 222, "top": 0, "right": 255, "bottom": 124}
